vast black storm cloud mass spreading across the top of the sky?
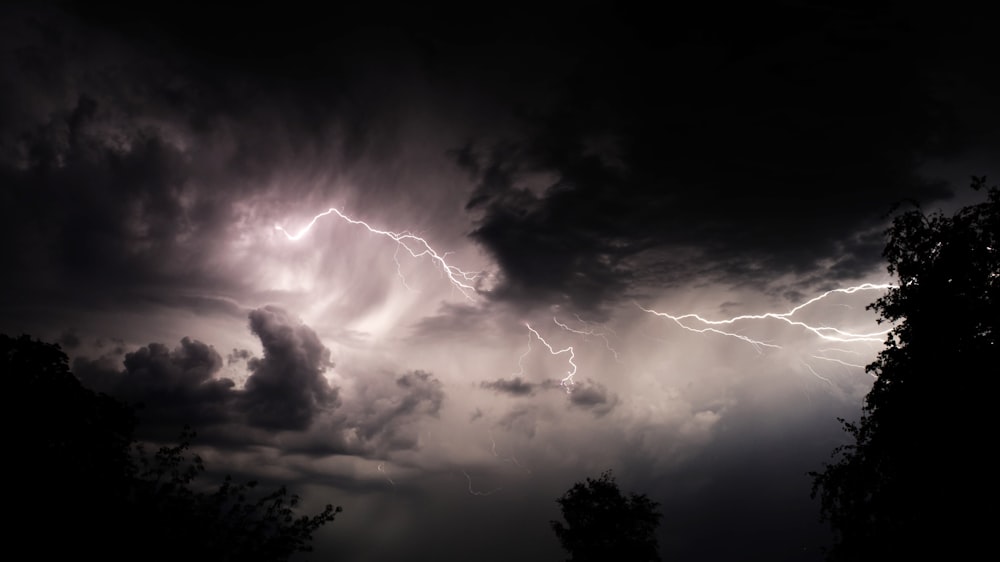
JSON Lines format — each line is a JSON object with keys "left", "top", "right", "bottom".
{"left": 13, "top": 5, "right": 997, "bottom": 320}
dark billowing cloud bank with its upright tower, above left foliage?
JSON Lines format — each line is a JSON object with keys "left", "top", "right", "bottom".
{"left": 74, "top": 307, "right": 339, "bottom": 434}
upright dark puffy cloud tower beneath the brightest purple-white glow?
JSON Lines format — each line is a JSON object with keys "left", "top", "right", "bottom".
{"left": 238, "top": 306, "right": 339, "bottom": 430}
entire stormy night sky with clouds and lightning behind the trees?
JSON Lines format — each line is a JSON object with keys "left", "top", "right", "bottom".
{"left": 0, "top": 1, "right": 1000, "bottom": 562}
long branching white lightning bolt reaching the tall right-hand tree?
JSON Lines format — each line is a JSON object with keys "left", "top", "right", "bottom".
{"left": 635, "top": 283, "right": 895, "bottom": 352}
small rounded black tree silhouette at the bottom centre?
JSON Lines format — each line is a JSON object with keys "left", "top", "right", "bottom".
{"left": 550, "top": 470, "right": 662, "bottom": 562}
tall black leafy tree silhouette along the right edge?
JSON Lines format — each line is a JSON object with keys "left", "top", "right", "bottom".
{"left": 811, "top": 177, "right": 1000, "bottom": 560}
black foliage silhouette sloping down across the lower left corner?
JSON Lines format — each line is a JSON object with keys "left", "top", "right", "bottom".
{"left": 0, "top": 334, "right": 341, "bottom": 561}
